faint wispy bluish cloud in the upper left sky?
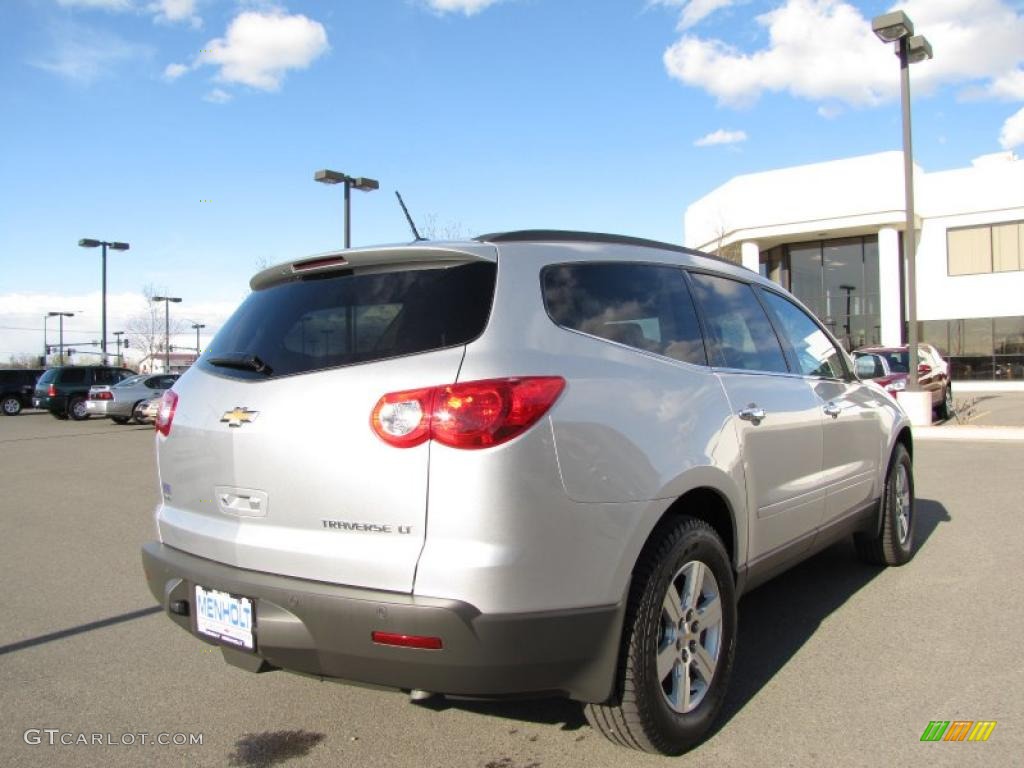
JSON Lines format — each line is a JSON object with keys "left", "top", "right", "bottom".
{"left": 30, "top": 25, "right": 153, "bottom": 84}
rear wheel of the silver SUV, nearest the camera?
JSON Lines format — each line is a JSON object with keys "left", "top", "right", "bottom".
{"left": 584, "top": 517, "right": 736, "bottom": 755}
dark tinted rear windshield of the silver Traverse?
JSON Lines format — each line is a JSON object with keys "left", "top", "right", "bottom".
{"left": 200, "top": 262, "right": 497, "bottom": 379}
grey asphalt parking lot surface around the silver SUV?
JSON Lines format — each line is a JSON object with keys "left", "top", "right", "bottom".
{"left": 0, "top": 412, "right": 1024, "bottom": 768}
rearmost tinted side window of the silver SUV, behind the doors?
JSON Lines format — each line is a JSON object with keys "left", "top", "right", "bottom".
{"left": 542, "top": 264, "right": 708, "bottom": 366}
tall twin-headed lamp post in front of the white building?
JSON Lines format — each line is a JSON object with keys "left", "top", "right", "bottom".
{"left": 871, "top": 10, "right": 932, "bottom": 420}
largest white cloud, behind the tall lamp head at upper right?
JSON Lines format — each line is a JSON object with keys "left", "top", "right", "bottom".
{"left": 664, "top": 0, "right": 1024, "bottom": 106}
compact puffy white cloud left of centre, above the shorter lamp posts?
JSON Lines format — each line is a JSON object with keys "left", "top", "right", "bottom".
{"left": 196, "top": 10, "right": 329, "bottom": 91}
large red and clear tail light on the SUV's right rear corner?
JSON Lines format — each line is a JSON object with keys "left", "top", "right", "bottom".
{"left": 370, "top": 376, "right": 565, "bottom": 449}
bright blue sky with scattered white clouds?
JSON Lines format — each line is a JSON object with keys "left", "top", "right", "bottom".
{"left": 0, "top": 0, "right": 1024, "bottom": 357}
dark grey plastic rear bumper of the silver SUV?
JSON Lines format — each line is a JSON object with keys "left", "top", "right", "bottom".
{"left": 142, "top": 542, "right": 625, "bottom": 701}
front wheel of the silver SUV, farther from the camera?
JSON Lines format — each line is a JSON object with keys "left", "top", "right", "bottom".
{"left": 853, "top": 443, "right": 918, "bottom": 565}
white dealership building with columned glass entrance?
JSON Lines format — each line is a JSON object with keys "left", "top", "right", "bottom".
{"left": 685, "top": 152, "right": 1024, "bottom": 379}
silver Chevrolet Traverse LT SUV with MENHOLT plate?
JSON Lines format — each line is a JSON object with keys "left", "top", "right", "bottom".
{"left": 142, "top": 231, "right": 914, "bottom": 754}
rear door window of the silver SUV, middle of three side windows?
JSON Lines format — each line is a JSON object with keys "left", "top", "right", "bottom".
{"left": 692, "top": 273, "right": 788, "bottom": 373}
